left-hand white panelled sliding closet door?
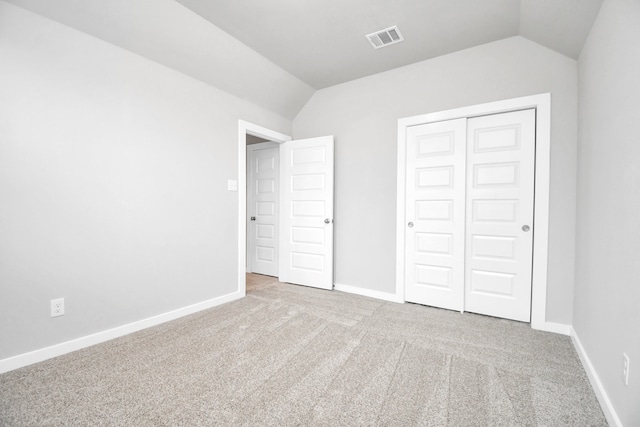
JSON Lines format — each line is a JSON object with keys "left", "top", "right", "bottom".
{"left": 405, "top": 119, "right": 466, "bottom": 311}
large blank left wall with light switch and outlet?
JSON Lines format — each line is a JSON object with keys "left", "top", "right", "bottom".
{"left": 0, "top": 2, "right": 291, "bottom": 359}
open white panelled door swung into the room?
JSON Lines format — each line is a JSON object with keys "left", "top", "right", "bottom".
{"left": 280, "top": 136, "right": 334, "bottom": 289}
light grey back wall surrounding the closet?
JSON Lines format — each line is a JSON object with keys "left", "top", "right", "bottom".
{"left": 293, "top": 37, "right": 577, "bottom": 325}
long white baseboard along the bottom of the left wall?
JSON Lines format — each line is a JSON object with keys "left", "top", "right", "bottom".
{"left": 0, "top": 291, "right": 243, "bottom": 374}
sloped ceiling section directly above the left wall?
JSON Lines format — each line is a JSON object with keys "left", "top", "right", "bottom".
{"left": 5, "top": 0, "right": 313, "bottom": 119}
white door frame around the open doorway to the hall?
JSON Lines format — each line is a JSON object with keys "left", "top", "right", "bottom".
{"left": 238, "top": 120, "right": 292, "bottom": 297}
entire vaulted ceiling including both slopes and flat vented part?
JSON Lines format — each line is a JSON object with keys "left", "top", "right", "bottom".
{"left": 0, "top": 0, "right": 603, "bottom": 118}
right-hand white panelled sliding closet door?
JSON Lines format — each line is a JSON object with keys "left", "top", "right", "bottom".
{"left": 465, "top": 109, "right": 536, "bottom": 322}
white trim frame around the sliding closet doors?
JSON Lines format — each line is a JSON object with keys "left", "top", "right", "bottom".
{"left": 396, "top": 93, "right": 559, "bottom": 332}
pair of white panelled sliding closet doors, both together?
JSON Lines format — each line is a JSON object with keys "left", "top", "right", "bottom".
{"left": 405, "top": 109, "right": 535, "bottom": 322}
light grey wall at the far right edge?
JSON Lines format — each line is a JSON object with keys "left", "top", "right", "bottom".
{"left": 573, "top": 0, "right": 640, "bottom": 426}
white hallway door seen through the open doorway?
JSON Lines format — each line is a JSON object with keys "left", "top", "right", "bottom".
{"left": 247, "top": 142, "right": 280, "bottom": 277}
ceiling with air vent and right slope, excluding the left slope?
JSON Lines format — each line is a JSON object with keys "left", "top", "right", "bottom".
{"left": 177, "top": 0, "right": 602, "bottom": 89}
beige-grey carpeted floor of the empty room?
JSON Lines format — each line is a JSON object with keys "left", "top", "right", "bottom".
{"left": 0, "top": 275, "right": 606, "bottom": 427}
